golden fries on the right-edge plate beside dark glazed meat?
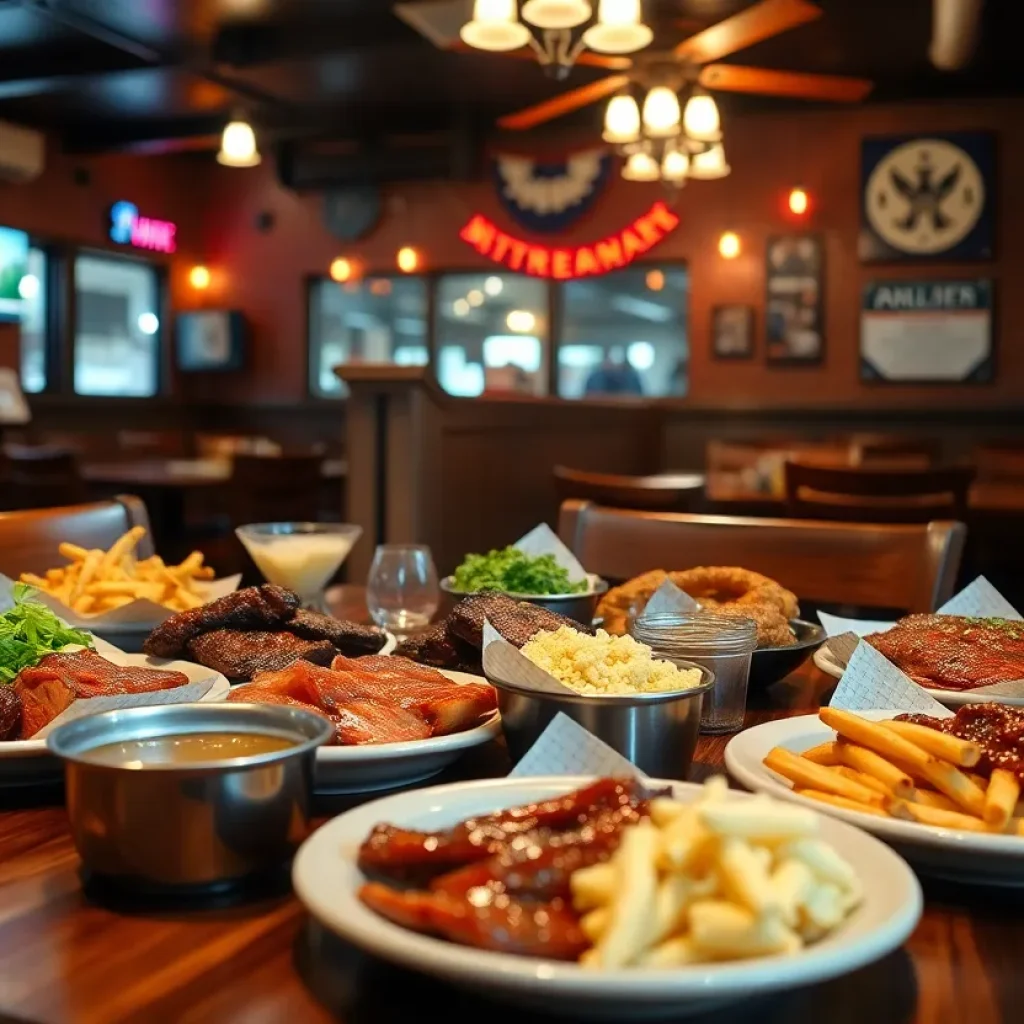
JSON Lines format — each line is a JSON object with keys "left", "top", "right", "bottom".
{"left": 764, "top": 708, "right": 1024, "bottom": 836}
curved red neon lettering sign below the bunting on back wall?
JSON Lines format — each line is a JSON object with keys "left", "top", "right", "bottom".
{"left": 459, "top": 203, "right": 679, "bottom": 281}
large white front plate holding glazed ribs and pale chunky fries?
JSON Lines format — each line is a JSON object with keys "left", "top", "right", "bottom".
{"left": 292, "top": 776, "right": 922, "bottom": 1020}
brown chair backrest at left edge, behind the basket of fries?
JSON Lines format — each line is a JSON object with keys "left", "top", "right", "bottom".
{"left": 0, "top": 495, "right": 153, "bottom": 580}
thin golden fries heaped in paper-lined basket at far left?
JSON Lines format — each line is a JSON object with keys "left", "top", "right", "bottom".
{"left": 20, "top": 526, "right": 213, "bottom": 615}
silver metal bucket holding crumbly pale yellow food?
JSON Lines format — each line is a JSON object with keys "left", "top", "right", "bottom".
{"left": 490, "top": 659, "right": 715, "bottom": 779}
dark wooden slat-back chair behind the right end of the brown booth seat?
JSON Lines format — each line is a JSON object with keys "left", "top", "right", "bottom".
{"left": 785, "top": 462, "right": 975, "bottom": 522}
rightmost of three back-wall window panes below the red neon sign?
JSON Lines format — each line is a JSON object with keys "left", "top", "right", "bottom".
{"left": 558, "top": 265, "right": 689, "bottom": 398}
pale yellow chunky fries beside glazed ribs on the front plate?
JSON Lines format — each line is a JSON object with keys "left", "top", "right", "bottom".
{"left": 571, "top": 778, "right": 862, "bottom": 970}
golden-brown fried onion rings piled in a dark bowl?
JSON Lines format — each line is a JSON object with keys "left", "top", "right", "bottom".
{"left": 597, "top": 565, "right": 800, "bottom": 647}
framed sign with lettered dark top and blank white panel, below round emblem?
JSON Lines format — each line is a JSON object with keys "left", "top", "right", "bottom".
{"left": 860, "top": 278, "right": 993, "bottom": 384}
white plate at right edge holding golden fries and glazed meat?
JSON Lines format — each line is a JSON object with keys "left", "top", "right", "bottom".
{"left": 725, "top": 711, "right": 1024, "bottom": 886}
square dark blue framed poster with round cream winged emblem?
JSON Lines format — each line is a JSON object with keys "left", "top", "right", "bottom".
{"left": 859, "top": 132, "right": 995, "bottom": 263}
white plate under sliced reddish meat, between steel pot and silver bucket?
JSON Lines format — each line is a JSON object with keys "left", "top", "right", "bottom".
{"left": 316, "top": 669, "right": 502, "bottom": 794}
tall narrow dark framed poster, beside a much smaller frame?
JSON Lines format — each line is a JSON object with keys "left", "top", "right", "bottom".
{"left": 765, "top": 234, "right": 825, "bottom": 364}
